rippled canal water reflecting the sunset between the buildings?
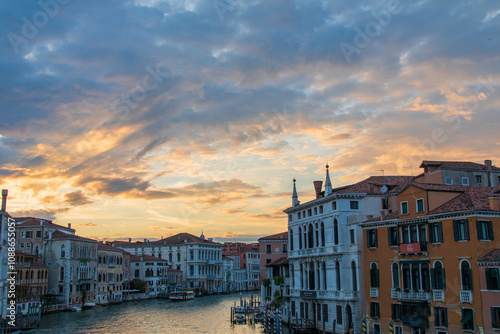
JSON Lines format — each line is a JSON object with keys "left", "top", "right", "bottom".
{"left": 37, "top": 292, "right": 280, "bottom": 334}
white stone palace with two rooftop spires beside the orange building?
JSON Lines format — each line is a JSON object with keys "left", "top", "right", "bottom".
{"left": 284, "top": 165, "right": 412, "bottom": 333}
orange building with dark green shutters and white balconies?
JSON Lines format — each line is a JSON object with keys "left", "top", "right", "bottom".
{"left": 362, "top": 183, "right": 500, "bottom": 334}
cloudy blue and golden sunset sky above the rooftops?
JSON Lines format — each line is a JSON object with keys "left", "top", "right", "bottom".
{"left": 0, "top": 0, "right": 500, "bottom": 242}
